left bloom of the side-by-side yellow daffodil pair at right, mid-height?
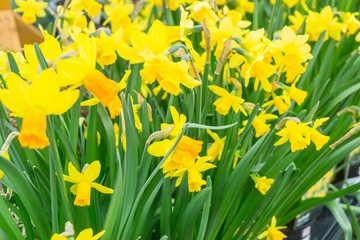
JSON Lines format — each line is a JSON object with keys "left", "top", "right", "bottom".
{"left": 274, "top": 121, "right": 310, "bottom": 152}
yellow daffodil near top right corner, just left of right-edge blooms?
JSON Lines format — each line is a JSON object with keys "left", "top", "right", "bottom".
{"left": 305, "top": 6, "right": 344, "bottom": 41}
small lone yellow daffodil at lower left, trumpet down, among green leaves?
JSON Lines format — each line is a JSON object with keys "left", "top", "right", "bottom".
{"left": 63, "top": 161, "right": 114, "bottom": 207}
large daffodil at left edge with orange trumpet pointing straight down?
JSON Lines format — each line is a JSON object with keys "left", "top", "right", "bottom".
{"left": 0, "top": 69, "right": 79, "bottom": 148}
